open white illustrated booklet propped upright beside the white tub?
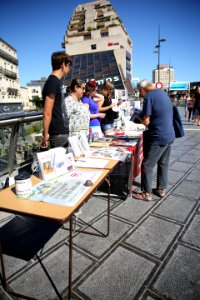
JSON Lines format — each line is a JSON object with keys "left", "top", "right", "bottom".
{"left": 37, "top": 147, "right": 75, "bottom": 180}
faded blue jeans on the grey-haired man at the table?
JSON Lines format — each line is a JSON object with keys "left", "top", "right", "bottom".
{"left": 141, "top": 144, "right": 171, "bottom": 193}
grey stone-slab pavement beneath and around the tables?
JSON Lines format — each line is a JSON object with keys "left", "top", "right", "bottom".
{"left": 0, "top": 109, "right": 200, "bottom": 300}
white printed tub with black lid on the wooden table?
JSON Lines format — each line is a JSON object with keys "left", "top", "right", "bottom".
{"left": 15, "top": 173, "right": 32, "bottom": 198}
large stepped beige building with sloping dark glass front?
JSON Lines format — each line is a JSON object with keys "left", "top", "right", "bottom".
{"left": 62, "top": 0, "right": 133, "bottom": 92}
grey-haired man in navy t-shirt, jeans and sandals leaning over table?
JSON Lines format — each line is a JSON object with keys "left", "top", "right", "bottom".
{"left": 133, "top": 79, "right": 175, "bottom": 201}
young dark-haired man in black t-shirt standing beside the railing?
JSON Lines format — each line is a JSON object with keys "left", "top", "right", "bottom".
{"left": 41, "top": 51, "right": 72, "bottom": 149}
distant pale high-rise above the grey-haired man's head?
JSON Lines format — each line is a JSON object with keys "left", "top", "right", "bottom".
{"left": 153, "top": 64, "right": 174, "bottom": 89}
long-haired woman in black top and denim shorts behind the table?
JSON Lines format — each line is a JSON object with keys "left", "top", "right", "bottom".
{"left": 99, "top": 81, "right": 121, "bottom": 134}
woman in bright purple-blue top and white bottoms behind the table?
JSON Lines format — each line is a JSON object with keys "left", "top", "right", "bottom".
{"left": 82, "top": 80, "right": 105, "bottom": 137}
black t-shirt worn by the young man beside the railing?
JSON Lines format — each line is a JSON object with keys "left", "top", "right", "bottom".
{"left": 42, "top": 75, "right": 68, "bottom": 135}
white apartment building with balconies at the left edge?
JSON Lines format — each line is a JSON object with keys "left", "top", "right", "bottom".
{"left": 0, "top": 38, "right": 22, "bottom": 113}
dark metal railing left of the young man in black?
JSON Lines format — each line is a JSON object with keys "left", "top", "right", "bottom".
{"left": 0, "top": 110, "right": 43, "bottom": 177}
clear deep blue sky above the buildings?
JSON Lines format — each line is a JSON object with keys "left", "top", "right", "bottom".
{"left": 0, "top": 0, "right": 200, "bottom": 86}
